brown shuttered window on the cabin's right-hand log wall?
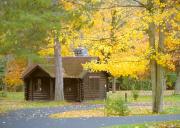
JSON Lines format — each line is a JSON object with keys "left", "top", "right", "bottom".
{"left": 89, "top": 76, "right": 100, "bottom": 90}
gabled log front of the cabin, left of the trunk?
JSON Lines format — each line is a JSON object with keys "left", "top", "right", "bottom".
{"left": 24, "top": 69, "right": 54, "bottom": 100}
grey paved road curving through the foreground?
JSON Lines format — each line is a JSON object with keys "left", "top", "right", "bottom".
{"left": 0, "top": 105, "right": 180, "bottom": 128}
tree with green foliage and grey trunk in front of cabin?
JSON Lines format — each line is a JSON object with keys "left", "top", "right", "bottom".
{"left": 0, "top": 0, "right": 98, "bottom": 100}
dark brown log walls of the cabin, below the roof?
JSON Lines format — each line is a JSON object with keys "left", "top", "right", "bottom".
{"left": 24, "top": 66, "right": 107, "bottom": 101}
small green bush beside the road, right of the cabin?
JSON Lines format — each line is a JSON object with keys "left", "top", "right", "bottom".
{"left": 105, "top": 96, "right": 128, "bottom": 116}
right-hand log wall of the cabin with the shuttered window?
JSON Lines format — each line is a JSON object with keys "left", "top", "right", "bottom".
{"left": 83, "top": 72, "right": 107, "bottom": 100}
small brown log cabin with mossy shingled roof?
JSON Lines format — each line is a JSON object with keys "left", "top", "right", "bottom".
{"left": 22, "top": 57, "right": 108, "bottom": 101}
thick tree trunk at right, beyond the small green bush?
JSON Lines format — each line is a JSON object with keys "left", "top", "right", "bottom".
{"left": 148, "top": 4, "right": 165, "bottom": 113}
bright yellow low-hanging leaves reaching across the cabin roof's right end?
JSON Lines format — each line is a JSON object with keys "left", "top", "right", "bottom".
{"left": 83, "top": 55, "right": 149, "bottom": 77}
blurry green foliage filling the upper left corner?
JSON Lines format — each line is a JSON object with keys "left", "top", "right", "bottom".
{"left": 0, "top": 0, "right": 66, "bottom": 54}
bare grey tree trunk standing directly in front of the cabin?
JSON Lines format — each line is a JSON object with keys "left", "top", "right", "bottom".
{"left": 54, "top": 37, "right": 64, "bottom": 101}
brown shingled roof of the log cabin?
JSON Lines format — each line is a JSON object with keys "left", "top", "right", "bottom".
{"left": 22, "top": 57, "right": 98, "bottom": 79}
